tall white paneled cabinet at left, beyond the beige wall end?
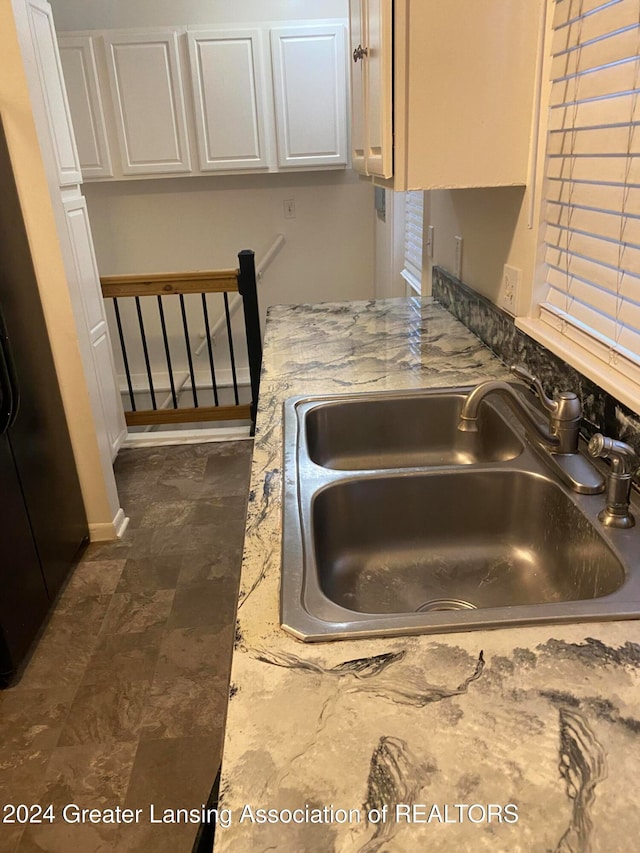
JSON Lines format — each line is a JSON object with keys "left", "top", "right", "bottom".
{"left": 14, "top": 0, "right": 126, "bottom": 539}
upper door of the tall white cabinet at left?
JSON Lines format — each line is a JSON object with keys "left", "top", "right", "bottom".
{"left": 26, "top": 0, "right": 82, "bottom": 187}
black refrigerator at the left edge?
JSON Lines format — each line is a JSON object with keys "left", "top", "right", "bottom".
{"left": 0, "top": 116, "right": 88, "bottom": 686}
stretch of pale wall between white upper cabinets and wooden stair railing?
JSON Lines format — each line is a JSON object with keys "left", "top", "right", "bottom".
{"left": 84, "top": 170, "right": 374, "bottom": 310}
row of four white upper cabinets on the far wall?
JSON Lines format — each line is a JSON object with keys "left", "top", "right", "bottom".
{"left": 56, "top": 20, "right": 350, "bottom": 180}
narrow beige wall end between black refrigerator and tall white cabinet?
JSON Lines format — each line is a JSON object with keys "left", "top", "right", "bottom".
{"left": 0, "top": 0, "right": 113, "bottom": 525}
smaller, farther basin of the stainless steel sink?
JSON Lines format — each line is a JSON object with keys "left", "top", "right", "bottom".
{"left": 303, "top": 389, "right": 522, "bottom": 471}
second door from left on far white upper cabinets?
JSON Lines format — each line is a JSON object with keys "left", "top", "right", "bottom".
{"left": 104, "top": 31, "right": 191, "bottom": 175}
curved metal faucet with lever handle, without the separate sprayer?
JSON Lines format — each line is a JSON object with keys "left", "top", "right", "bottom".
{"left": 458, "top": 365, "right": 605, "bottom": 494}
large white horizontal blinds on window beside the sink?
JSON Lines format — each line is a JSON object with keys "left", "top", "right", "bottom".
{"left": 541, "top": 0, "right": 640, "bottom": 382}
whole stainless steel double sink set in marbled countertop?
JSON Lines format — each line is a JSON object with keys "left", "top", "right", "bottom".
{"left": 281, "top": 386, "right": 640, "bottom": 641}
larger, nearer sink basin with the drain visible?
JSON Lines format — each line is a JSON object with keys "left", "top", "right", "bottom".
{"left": 311, "top": 470, "right": 625, "bottom": 613}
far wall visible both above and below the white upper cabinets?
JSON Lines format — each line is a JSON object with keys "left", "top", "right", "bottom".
{"left": 52, "top": 0, "right": 375, "bottom": 392}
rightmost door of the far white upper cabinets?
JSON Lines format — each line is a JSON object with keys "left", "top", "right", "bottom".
{"left": 271, "top": 24, "right": 347, "bottom": 168}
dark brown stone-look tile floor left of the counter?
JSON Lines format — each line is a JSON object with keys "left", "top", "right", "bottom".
{"left": 0, "top": 441, "right": 252, "bottom": 853}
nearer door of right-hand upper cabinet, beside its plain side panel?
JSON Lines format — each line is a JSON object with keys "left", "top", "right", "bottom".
{"left": 363, "top": 0, "right": 392, "bottom": 178}
